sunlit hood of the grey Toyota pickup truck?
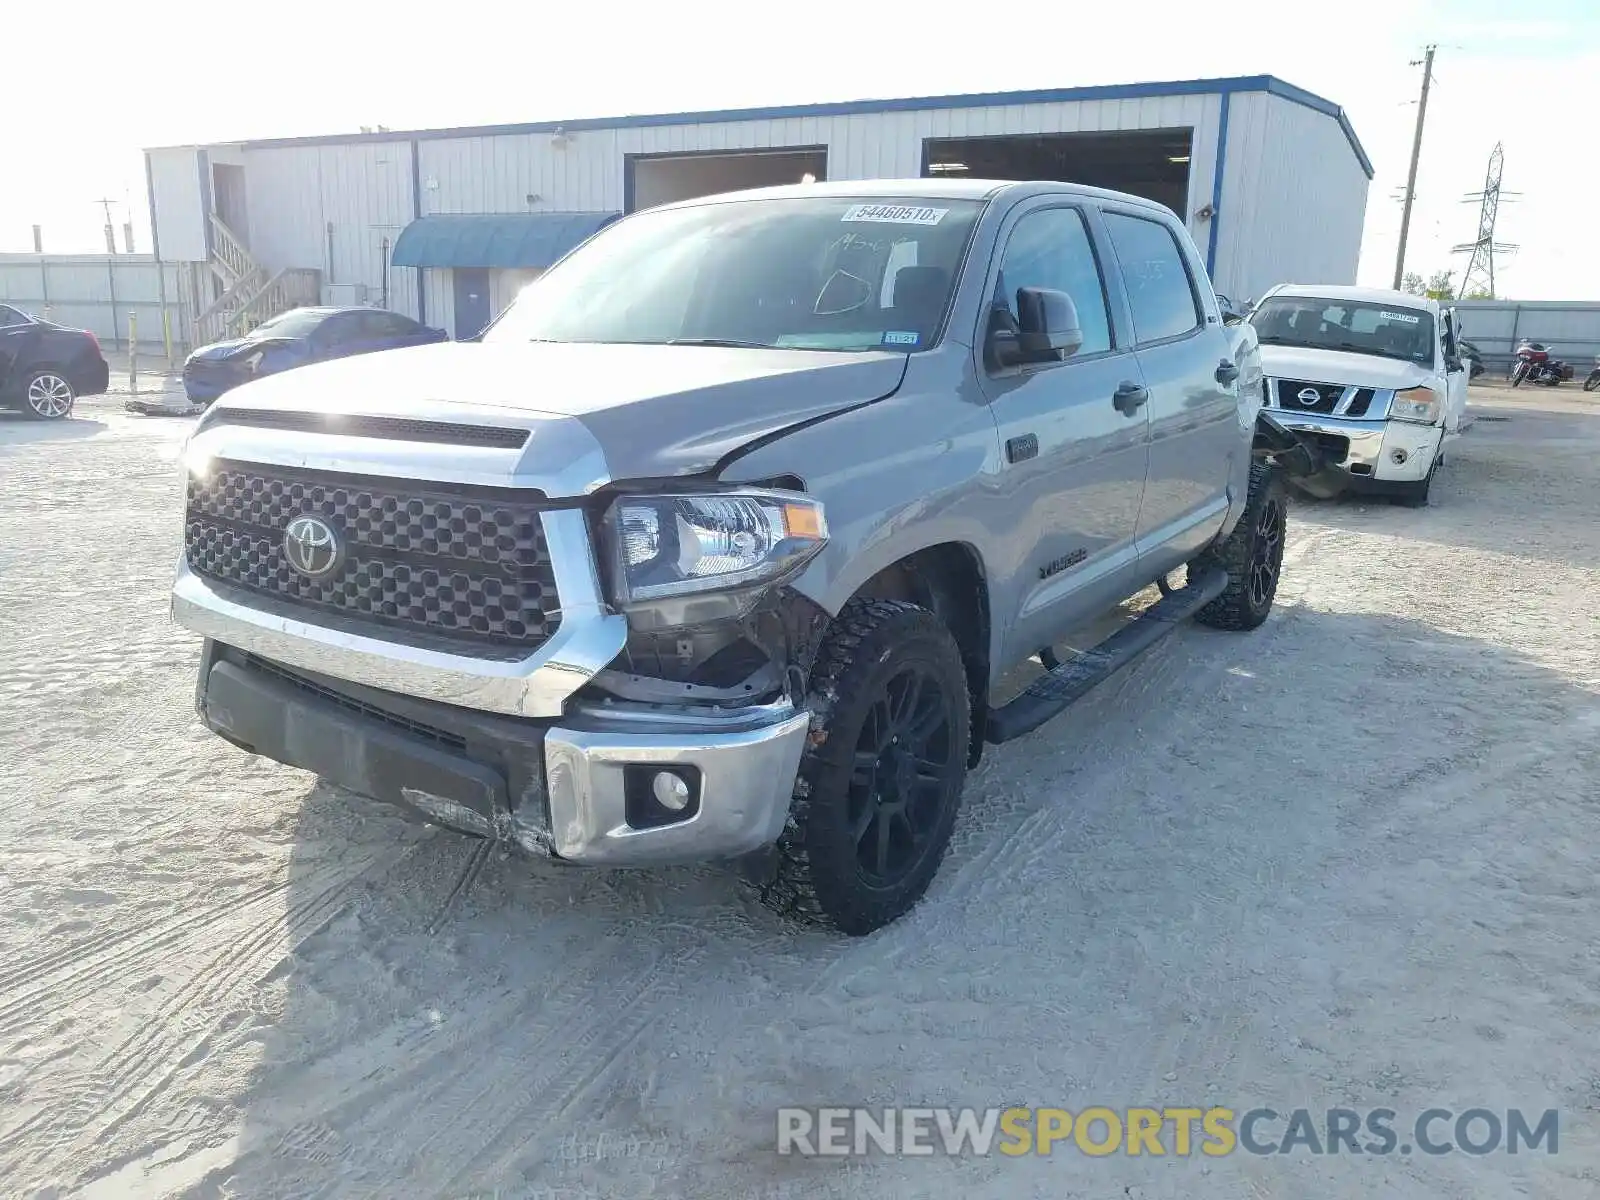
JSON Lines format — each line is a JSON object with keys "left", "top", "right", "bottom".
{"left": 216, "top": 342, "right": 906, "bottom": 480}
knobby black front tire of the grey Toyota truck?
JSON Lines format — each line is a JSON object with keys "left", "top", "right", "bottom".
{"left": 758, "top": 600, "right": 971, "bottom": 936}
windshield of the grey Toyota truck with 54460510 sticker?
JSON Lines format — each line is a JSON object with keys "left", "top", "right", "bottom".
{"left": 483, "top": 197, "right": 982, "bottom": 350}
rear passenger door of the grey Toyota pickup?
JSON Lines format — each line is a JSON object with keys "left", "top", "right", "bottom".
{"left": 1101, "top": 205, "right": 1250, "bottom": 573}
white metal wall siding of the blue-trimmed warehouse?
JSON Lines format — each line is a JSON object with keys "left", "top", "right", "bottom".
{"left": 200, "top": 85, "right": 1368, "bottom": 328}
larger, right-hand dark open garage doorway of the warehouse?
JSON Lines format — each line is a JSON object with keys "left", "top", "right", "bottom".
{"left": 923, "top": 128, "right": 1194, "bottom": 218}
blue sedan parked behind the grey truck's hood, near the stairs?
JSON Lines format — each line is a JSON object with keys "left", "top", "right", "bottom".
{"left": 184, "top": 307, "right": 450, "bottom": 405}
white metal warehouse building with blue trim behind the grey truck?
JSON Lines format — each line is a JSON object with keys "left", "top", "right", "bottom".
{"left": 146, "top": 75, "right": 1373, "bottom": 339}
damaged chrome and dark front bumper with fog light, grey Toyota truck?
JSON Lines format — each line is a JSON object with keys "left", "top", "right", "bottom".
{"left": 195, "top": 640, "right": 810, "bottom": 867}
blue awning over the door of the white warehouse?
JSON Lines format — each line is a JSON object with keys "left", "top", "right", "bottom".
{"left": 389, "top": 213, "right": 621, "bottom": 267}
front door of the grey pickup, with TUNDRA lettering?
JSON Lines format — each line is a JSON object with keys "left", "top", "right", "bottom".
{"left": 974, "top": 197, "right": 1149, "bottom": 661}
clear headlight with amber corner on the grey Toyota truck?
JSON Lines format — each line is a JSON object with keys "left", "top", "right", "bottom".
{"left": 608, "top": 491, "right": 827, "bottom": 605}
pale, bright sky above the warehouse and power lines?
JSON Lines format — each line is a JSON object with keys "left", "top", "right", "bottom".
{"left": 0, "top": 0, "right": 1600, "bottom": 299}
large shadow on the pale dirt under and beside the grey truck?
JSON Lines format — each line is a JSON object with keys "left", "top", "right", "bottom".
{"left": 206, "top": 608, "right": 1600, "bottom": 1200}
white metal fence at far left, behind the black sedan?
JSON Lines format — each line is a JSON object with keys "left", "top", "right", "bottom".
{"left": 0, "top": 254, "right": 194, "bottom": 354}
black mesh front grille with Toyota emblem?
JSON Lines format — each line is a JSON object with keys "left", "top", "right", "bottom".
{"left": 184, "top": 462, "right": 562, "bottom": 653}
